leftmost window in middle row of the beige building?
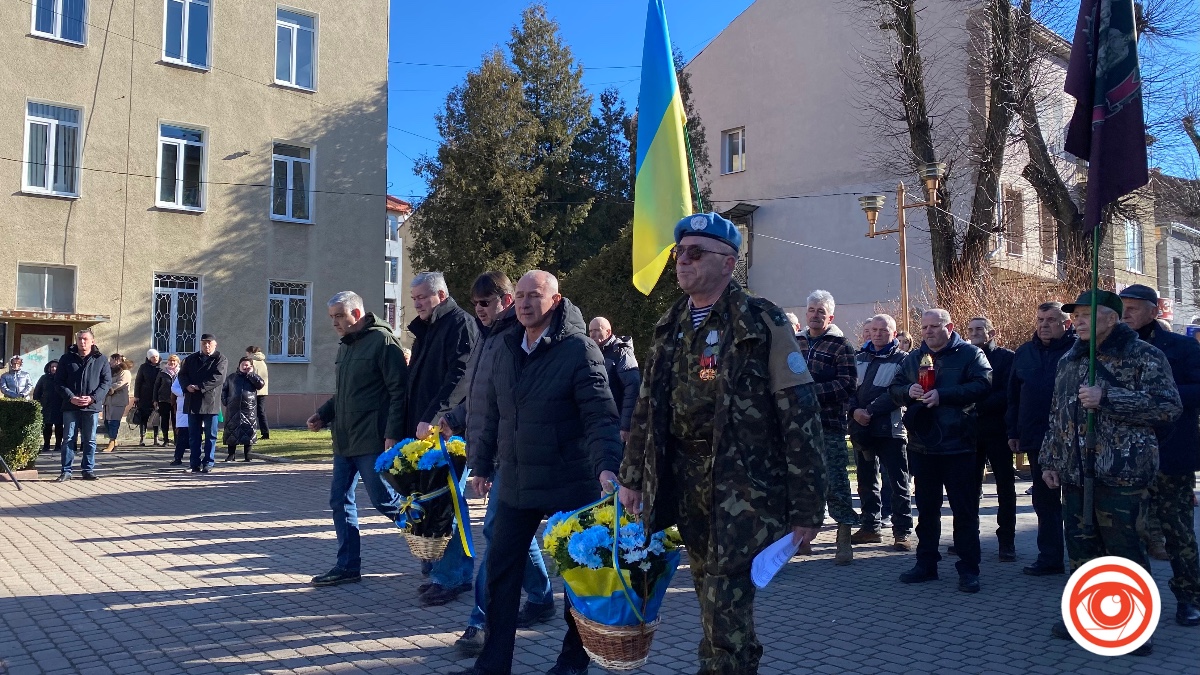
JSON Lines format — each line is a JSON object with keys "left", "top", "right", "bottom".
{"left": 22, "top": 102, "right": 80, "bottom": 197}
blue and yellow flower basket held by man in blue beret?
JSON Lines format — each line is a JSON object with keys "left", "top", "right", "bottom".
{"left": 542, "top": 482, "right": 682, "bottom": 670}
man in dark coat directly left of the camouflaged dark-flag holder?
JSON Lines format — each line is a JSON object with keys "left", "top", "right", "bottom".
{"left": 1004, "top": 303, "right": 1076, "bottom": 577}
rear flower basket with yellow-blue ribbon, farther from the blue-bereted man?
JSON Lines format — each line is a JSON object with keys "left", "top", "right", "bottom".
{"left": 374, "top": 426, "right": 474, "bottom": 561}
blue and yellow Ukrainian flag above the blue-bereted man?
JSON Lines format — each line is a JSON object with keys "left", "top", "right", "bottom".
{"left": 634, "top": 0, "right": 691, "bottom": 295}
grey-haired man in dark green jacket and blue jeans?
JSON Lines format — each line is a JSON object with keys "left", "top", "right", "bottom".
{"left": 308, "top": 291, "right": 408, "bottom": 586}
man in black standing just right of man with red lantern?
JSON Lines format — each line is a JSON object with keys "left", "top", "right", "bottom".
{"left": 967, "top": 316, "right": 1016, "bottom": 562}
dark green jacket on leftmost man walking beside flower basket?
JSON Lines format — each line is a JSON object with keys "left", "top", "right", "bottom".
{"left": 317, "top": 313, "right": 408, "bottom": 456}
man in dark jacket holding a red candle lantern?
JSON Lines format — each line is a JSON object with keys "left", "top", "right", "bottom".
{"left": 889, "top": 309, "right": 991, "bottom": 593}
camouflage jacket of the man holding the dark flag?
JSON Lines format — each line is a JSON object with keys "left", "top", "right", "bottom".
{"left": 1038, "top": 323, "right": 1183, "bottom": 488}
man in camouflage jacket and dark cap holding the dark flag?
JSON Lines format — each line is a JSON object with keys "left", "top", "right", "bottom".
{"left": 1039, "top": 291, "right": 1182, "bottom": 655}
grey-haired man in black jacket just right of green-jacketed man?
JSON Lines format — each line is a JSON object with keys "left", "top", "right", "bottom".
{"left": 404, "top": 271, "right": 479, "bottom": 607}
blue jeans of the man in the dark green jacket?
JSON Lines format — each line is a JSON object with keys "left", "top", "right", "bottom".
{"left": 329, "top": 450, "right": 400, "bottom": 572}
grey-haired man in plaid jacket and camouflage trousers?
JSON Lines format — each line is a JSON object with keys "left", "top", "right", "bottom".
{"left": 796, "top": 285, "right": 859, "bottom": 565}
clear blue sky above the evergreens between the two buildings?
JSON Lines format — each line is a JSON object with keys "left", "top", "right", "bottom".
{"left": 388, "top": 0, "right": 752, "bottom": 199}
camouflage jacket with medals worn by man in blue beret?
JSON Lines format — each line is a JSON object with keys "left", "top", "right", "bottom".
{"left": 620, "top": 282, "right": 826, "bottom": 574}
